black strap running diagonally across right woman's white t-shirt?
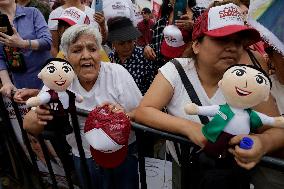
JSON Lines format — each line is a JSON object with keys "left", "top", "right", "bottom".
{"left": 171, "top": 59, "right": 209, "bottom": 125}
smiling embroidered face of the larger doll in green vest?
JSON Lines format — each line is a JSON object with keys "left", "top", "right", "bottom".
{"left": 219, "top": 65, "right": 270, "bottom": 109}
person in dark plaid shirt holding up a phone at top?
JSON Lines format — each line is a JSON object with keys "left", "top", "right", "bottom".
{"left": 144, "top": 0, "right": 205, "bottom": 67}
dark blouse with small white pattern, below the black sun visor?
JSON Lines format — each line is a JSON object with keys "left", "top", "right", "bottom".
{"left": 109, "top": 46, "right": 157, "bottom": 95}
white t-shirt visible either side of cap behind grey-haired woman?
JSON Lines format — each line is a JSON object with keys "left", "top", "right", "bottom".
{"left": 48, "top": 6, "right": 98, "bottom": 30}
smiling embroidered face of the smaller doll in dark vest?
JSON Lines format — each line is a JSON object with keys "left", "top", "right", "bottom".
{"left": 38, "top": 60, "right": 75, "bottom": 92}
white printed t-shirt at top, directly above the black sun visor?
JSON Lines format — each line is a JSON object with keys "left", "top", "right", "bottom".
{"left": 91, "top": 0, "right": 135, "bottom": 23}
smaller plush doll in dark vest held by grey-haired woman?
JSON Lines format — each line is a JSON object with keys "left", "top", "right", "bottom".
{"left": 26, "top": 58, "right": 83, "bottom": 134}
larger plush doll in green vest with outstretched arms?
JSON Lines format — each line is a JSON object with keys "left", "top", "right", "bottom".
{"left": 185, "top": 65, "right": 284, "bottom": 158}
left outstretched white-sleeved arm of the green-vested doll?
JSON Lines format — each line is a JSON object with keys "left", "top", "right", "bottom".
{"left": 184, "top": 103, "right": 220, "bottom": 117}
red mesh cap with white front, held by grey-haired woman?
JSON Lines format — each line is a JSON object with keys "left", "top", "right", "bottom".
{"left": 84, "top": 105, "right": 131, "bottom": 168}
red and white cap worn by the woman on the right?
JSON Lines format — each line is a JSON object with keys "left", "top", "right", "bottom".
{"left": 192, "top": 3, "right": 261, "bottom": 46}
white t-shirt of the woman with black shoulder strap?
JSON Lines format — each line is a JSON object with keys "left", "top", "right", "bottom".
{"left": 159, "top": 58, "right": 226, "bottom": 122}
